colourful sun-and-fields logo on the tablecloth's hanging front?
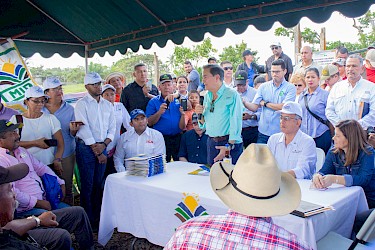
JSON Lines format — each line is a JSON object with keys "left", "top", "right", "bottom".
{"left": 174, "top": 193, "right": 208, "bottom": 222}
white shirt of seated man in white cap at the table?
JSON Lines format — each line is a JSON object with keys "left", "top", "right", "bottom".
{"left": 267, "top": 130, "right": 317, "bottom": 179}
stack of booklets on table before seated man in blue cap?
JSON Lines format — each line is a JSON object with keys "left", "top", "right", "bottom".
{"left": 125, "top": 154, "right": 167, "bottom": 177}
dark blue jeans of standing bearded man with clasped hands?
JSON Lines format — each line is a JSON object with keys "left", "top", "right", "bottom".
{"left": 76, "top": 140, "right": 107, "bottom": 226}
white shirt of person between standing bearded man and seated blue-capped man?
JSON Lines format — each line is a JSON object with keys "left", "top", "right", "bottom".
{"left": 107, "top": 102, "right": 133, "bottom": 152}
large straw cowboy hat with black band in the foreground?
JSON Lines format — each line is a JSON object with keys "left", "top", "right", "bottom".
{"left": 210, "top": 143, "right": 301, "bottom": 217}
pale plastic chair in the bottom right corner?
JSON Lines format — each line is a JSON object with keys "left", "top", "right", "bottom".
{"left": 317, "top": 210, "right": 375, "bottom": 250}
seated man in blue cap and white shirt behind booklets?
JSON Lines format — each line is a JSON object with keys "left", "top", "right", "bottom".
{"left": 113, "top": 109, "right": 165, "bottom": 172}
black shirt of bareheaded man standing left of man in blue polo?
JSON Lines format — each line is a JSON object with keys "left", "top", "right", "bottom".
{"left": 121, "top": 81, "right": 159, "bottom": 113}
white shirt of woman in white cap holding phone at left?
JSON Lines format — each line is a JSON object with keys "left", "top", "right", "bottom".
{"left": 10, "top": 113, "right": 61, "bottom": 165}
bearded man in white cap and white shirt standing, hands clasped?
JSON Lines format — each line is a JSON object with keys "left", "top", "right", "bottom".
{"left": 74, "top": 72, "right": 116, "bottom": 229}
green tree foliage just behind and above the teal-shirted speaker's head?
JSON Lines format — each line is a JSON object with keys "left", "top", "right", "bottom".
{"left": 167, "top": 38, "right": 217, "bottom": 75}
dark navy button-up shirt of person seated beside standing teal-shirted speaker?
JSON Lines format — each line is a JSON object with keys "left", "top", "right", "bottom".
{"left": 178, "top": 129, "right": 208, "bottom": 164}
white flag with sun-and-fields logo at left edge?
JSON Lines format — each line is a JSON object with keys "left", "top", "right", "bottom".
{"left": 0, "top": 39, "right": 37, "bottom": 109}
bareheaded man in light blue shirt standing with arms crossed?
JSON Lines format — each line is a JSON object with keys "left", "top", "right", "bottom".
{"left": 244, "top": 59, "right": 296, "bottom": 143}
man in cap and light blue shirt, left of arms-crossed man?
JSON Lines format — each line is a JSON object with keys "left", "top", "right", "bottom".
{"left": 234, "top": 70, "right": 261, "bottom": 148}
